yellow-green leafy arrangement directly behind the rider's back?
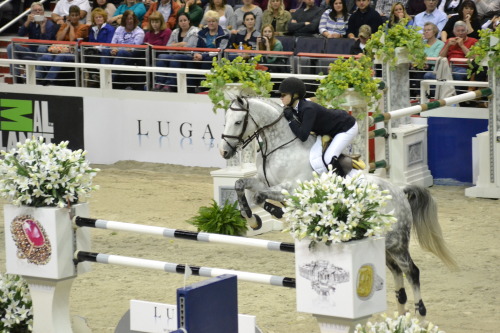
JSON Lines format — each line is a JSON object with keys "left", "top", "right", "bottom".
{"left": 316, "top": 55, "right": 382, "bottom": 116}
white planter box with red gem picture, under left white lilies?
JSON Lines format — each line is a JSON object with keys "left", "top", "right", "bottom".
{"left": 4, "top": 203, "right": 90, "bottom": 280}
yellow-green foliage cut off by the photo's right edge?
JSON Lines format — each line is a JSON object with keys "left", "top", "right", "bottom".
{"left": 466, "top": 29, "right": 500, "bottom": 77}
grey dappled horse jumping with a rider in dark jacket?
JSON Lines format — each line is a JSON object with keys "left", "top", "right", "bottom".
{"left": 220, "top": 97, "right": 456, "bottom": 317}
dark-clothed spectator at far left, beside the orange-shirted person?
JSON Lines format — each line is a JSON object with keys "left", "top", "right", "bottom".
{"left": 7, "top": 2, "right": 59, "bottom": 81}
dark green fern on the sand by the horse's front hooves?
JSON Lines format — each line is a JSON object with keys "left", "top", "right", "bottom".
{"left": 187, "top": 200, "right": 247, "bottom": 236}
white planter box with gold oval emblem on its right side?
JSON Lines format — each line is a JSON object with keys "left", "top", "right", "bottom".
{"left": 295, "top": 238, "right": 386, "bottom": 319}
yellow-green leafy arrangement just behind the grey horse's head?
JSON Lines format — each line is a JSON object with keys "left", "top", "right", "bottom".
{"left": 201, "top": 54, "right": 273, "bottom": 113}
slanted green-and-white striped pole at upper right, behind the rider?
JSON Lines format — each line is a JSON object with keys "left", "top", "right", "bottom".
{"left": 369, "top": 88, "right": 493, "bottom": 125}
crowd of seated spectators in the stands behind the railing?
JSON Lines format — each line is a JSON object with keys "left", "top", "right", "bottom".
{"left": 4, "top": 0, "right": 500, "bottom": 91}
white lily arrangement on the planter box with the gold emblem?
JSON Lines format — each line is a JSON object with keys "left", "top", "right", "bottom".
{"left": 283, "top": 167, "right": 396, "bottom": 247}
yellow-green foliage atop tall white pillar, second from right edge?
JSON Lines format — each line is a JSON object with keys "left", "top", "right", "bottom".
{"left": 365, "top": 19, "right": 427, "bottom": 69}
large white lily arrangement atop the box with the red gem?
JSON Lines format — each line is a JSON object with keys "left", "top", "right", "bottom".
{"left": 0, "top": 137, "right": 99, "bottom": 207}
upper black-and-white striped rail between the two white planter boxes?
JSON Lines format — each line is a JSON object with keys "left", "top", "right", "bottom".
{"left": 73, "top": 216, "right": 295, "bottom": 253}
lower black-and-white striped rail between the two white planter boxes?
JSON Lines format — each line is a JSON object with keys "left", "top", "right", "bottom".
{"left": 75, "top": 251, "right": 295, "bottom": 288}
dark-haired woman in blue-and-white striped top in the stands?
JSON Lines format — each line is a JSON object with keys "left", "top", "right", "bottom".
{"left": 319, "top": 0, "right": 349, "bottom": 38}
